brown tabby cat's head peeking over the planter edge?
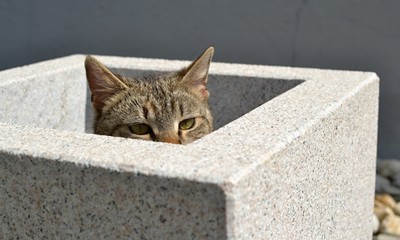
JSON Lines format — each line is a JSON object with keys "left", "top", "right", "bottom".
{"left": 85, "top": 47, "right": 214, "bottom": 144}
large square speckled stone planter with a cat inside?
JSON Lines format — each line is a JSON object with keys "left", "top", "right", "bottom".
{"left": 0, "top": 55, "right": 378, "bottom": 239}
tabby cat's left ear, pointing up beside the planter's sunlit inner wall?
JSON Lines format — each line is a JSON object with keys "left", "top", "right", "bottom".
{"left": 85, "top": 56, "right": 128, "bottom": 112}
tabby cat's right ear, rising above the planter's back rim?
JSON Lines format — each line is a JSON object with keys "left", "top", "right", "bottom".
{"left": 182, "top": 47, "right": 214, "bottom": 99}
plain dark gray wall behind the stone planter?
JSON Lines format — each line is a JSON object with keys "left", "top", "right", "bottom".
{"left": 0, "top": 0, "right": 400, "bottom": 158}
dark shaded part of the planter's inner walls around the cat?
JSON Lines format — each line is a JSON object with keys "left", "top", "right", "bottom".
{"left": 86, "top": 69, "right": 304, "bottom": 133}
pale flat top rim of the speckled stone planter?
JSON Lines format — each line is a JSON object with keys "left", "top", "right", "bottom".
{"left": 0, "top": 55, "right": 379, "bottom": 190}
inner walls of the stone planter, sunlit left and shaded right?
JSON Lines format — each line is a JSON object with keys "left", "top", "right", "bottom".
{"left": 0, "top": 66, "right": 303, "bottom": 133}
